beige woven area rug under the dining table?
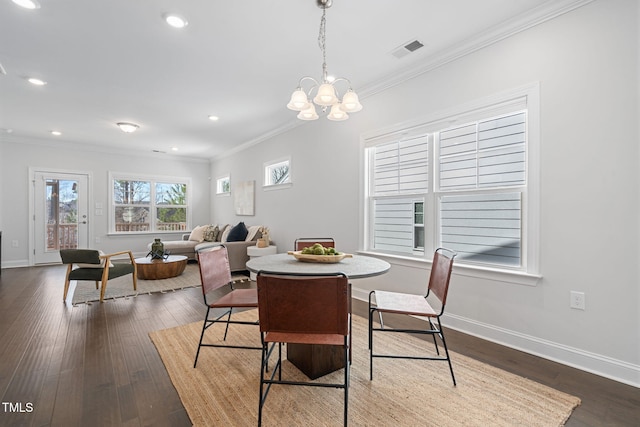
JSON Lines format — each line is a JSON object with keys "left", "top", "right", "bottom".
{"left": 150, "top": 310, "right": 580, "bottom": 427}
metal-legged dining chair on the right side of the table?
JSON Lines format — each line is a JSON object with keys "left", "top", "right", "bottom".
{"left": 369, "top": 248, "right": 456, "bottom": 386}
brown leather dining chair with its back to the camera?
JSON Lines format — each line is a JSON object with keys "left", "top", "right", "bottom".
{"left": 257, "top": 272, "right": 351, "bottom": 426}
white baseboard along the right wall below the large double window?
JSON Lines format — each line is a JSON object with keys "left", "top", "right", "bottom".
{"left": 352, "top": 288, "right": 640, "bottom": 387}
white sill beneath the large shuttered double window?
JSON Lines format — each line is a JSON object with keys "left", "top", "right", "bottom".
{"left": 358, "top": 251, "right": 542, "bottom": 286}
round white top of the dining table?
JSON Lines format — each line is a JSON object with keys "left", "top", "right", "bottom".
{"left": 247, "top": 253, "right": 391, "bottom": 279}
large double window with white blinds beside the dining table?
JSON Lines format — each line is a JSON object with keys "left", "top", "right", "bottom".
{"left": 363, "top": 84, "right": 539, "bottom": 277}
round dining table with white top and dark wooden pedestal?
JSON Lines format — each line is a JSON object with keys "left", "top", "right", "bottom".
{"left": 247, "top": 253, "right": 391, "bottom": 379}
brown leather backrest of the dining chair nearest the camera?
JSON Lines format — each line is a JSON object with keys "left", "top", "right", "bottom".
{"left": 257, "top": 272, "right": 351, "bottom": 336}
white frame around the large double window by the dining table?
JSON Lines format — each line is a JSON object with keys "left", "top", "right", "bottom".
{"left": 360, "top": 82, "right": 541, "bottom": 286}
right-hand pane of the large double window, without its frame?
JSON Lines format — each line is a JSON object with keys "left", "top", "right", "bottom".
{"left": 436, "top": 112, "right": 527, "bottom": 267}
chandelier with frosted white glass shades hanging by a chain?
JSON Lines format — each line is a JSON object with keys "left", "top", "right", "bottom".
{"left": 287, "top": 0, "right": 362, "bottom": 121}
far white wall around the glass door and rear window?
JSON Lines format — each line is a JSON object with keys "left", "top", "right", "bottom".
{"left": 0, "top": 140, "right": 210, "bottom": 267}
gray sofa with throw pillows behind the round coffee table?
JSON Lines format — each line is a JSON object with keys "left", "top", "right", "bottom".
{"left": 148, "top": 225, "right": 263, "bottom": 272}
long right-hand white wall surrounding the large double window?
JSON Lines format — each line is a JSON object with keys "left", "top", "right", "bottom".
{"left": 211, "top": 0, "right": 640, "bottom": 386}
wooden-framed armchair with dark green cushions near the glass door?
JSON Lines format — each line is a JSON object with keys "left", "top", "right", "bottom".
{"left": 60, "top": 249, "right": 138, "bottom": 302}
